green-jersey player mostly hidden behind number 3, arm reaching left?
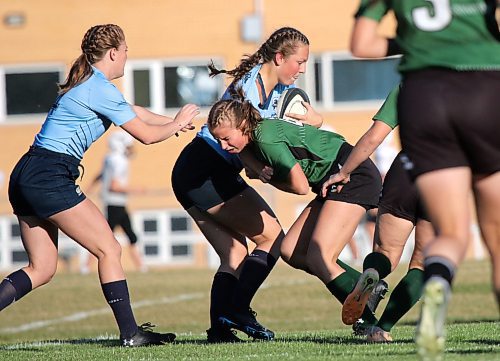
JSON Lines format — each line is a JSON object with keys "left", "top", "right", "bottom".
{"left": 322, "top": 85, "right": 434, "bottom": 342}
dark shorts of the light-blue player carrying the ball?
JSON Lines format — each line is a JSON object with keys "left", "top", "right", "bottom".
{"left": 172, "top": 137, "right": 249, "bottom": 211}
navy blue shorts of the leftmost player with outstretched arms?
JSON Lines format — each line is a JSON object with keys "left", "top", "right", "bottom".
{"left": 9, "top": 147, "right": 85, "bottom": 219}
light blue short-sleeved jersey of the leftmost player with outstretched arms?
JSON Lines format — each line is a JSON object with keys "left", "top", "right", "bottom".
{"left": 33, "top": 67, "right": 136, "bottom": 160}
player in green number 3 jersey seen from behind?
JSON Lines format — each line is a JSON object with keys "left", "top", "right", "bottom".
{"left": 351, "top": 0, "right": 500, "bottom": 360}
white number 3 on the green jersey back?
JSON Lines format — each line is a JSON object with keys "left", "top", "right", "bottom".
{"left": 412, "top": 0, "right": 451, "bottom": 31}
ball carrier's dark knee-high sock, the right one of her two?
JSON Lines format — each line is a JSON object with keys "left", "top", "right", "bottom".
{"left": 233, "top": 249, "right": 277, "bottom": 312}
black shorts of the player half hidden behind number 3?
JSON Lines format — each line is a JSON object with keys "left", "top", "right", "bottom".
{"left": 378, "top": 152, "right": 429, "bottom": 225}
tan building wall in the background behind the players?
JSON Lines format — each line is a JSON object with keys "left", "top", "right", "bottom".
{"left": 0, "top": 0, "right": 479, "bottom": 270}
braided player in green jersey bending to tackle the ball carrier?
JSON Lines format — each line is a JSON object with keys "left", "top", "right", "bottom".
{"left": 207, "top": 90, "right": 382, "bottom": 330}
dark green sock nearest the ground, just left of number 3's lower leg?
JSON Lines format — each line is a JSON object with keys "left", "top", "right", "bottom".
{"left": 377, "top": 268, "right": 424, "bottom": 332}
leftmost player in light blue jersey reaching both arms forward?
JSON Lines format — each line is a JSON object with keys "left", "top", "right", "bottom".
{"left": 5, "top": 24, "right": 199, "bottom": 347}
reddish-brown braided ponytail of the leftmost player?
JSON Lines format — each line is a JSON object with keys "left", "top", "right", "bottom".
{"left": 59, "top": 24, "right": 125, "bottom": 94}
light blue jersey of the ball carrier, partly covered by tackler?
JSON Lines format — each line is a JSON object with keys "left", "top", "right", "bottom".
{"left": 196, "top": 64, "right": 295, "bottom": 168}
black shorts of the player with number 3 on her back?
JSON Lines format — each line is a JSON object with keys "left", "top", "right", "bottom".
{"left": 398, "top": 68, "right": 500, "bottom": 177}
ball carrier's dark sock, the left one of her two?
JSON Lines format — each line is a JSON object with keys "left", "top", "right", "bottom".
{"left": 210, "top": 272, "right": 238, "bottom": 328}
